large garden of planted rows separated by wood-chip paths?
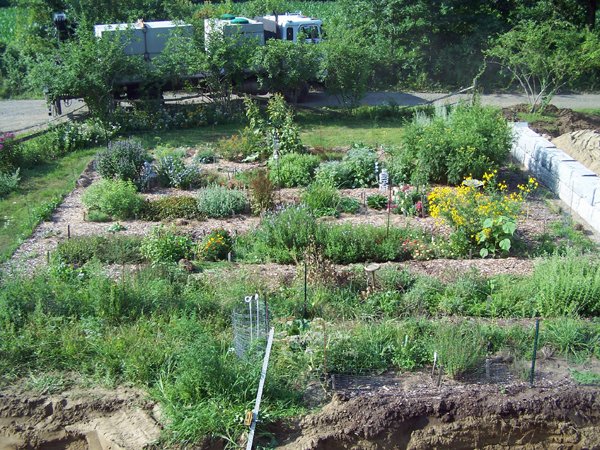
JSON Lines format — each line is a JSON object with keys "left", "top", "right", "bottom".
{"left": 0, "top": 96, "right": 600, "bottom": 448}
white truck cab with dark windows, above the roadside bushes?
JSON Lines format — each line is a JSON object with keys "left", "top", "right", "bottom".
{"left": 255, "top": 12, "right": 323, "bottom": 44}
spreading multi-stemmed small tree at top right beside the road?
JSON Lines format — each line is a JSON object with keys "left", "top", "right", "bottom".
{"left": 487, "top": 21, "right": 600, "bottom": 112}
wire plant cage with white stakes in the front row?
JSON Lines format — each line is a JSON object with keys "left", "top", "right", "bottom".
{"left": 232, "top": 294, "right": 270, "bottom": 358}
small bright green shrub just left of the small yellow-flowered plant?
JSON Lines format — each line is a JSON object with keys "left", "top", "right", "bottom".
{"left": 140, "top": 225, "right": 192, "bottom": 266}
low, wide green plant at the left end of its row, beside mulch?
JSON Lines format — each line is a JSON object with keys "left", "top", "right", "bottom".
{"left": 56, "top": 236, "right": 143, "bottom": 266}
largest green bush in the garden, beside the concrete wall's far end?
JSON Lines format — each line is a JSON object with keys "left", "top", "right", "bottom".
{"left": 398, "top": 105, "right": 512, "bottom": 185}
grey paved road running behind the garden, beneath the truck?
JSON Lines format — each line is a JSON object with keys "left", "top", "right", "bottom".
{"left": 0, "top": 92, "right": 600, "bottom": 132}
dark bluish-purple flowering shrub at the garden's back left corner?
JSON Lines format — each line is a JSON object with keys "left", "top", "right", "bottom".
{"left": 96, "top": 139, "right": 148, "bottom": 182}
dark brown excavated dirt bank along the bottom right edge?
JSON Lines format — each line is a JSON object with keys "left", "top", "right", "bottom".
{"left": 281, "top": 382, "right": 600, "bottom": 450}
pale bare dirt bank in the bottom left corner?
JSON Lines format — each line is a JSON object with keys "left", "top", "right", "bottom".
{"left": 0, "top": 386, "right": 161, "bottom": 450}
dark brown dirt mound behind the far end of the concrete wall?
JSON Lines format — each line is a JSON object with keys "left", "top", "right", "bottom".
{"left": 503, "top": 104, "right": 600, "bottom": 137}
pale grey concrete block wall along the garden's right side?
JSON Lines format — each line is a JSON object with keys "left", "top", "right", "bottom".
{"left": 511, "top": 122, "right": 600, "bottom": 232}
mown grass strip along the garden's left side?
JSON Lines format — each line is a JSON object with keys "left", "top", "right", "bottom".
{"left": 0, "top": 148, "right": 98, "bottom": 262}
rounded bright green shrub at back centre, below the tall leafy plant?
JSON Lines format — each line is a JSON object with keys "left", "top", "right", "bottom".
{"left": 268, "top": 153, "right": 320, "bottom": 188}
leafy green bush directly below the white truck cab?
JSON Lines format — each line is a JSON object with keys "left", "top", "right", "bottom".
{"left": 252, "top": 39, "right": 319, "bottom": 103}
